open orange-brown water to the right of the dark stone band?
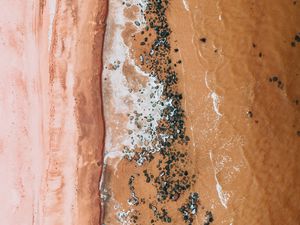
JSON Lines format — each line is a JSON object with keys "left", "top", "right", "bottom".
{"left": 170, "top": 1, "right": 300, "bottom": 224}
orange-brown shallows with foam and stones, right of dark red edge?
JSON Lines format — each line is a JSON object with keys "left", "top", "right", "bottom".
{"left": 102, "top": 0, "right": 300, "bottom": 225}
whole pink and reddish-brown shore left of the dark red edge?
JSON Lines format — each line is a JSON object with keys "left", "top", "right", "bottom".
{"left": 0, "top": 0, "right": 107, "bottom": 225}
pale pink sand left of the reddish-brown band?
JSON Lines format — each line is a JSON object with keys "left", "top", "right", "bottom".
{"left": 0, "top": 0, "right": 77, "bottom": 225}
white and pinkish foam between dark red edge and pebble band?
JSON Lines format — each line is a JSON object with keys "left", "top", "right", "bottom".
{"left": 100, "top": 0, "right": 167, "bottom": 221}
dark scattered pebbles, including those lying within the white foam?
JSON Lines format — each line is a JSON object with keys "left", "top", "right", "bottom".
{"left": 123, "top": 0, "right": 206, "bottom": 224}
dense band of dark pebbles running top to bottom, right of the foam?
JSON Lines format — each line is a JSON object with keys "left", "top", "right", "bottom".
{"left": 122, "top": 0, "right": 213, "bottom": 225}
